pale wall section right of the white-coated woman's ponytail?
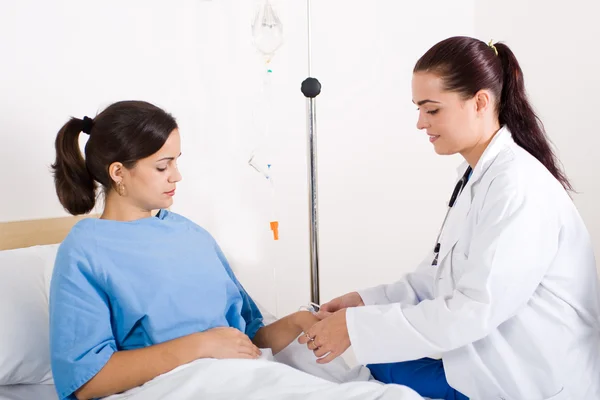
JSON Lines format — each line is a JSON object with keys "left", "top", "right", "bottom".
{"left": 475, "top": 0, "right": 600, "bottom": 266}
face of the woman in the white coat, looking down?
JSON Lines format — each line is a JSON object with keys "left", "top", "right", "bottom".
{"left": 412, "top": 72, "right": 478, "bottom": 155}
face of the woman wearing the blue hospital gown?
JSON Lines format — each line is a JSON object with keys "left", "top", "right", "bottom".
{"left": 123, "top": 129, "right": 181, "bottom": 210}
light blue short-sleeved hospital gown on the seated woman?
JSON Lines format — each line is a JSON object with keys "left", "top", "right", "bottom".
{"left": 50, "top": 210, "right": 263, "bottom": 400}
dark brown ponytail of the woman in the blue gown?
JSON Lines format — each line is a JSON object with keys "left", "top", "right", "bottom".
{"left": 52, "top": 118, "right": 96, "bottom": 215}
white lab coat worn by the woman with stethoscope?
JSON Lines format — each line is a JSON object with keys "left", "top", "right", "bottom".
{"left": 347, "top": 128, "right": 600, "bottom": 400}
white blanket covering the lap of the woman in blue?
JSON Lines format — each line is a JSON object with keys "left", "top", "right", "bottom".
{"left": 105, "top": 336, "right": 423, "bottom": 400}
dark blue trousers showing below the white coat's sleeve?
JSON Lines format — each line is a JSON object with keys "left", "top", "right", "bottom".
{"left": 367, "top": 358, "right": 468, "bottom": 400}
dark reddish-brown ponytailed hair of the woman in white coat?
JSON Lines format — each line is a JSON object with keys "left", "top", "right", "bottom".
{"left": 414, "top": 36, "right": 573, "bottom": 191}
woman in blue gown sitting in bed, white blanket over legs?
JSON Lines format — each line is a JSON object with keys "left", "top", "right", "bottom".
{"left": 50, "top": 101, "right": 424, "bottom": 400}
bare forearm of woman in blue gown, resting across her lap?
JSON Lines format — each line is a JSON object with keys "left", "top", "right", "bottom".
{"left": 75, "top": 335, "right": 203, "bottom": 400}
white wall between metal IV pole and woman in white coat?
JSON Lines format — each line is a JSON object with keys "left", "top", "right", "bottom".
{"left": 313, "top": 0, "right": 474, "bottom": 301}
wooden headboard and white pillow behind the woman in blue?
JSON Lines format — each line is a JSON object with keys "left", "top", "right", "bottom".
{"left": 0, "top": 217, "right": 90, "bottom": 400}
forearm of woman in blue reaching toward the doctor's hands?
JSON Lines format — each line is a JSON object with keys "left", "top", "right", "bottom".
{"left": 252, "top": 311, "right": 319, "bottom": 354}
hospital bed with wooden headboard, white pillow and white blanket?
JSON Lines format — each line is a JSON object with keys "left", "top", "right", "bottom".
{"left": 0, "top": 216, "right": 423, "bottom": 400}
